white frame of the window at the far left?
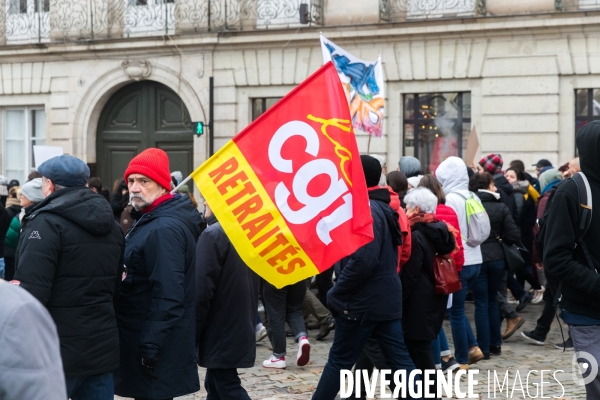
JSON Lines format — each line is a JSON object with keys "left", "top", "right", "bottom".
{"left": 2, "top": 105, "right": 48, "bottom": 181}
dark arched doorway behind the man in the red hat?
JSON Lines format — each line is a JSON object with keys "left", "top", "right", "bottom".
{"left": 96, "top": 81, "right": 194, "bottom": 190}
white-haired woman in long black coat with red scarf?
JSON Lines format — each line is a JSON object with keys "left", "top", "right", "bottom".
{"left": 400, "top": 187, "right": 458, "bottom": 390}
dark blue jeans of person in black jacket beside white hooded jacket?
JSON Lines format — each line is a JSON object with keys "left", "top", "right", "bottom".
{"left": 473, "top": 260, "right": 505, "bottom": 353}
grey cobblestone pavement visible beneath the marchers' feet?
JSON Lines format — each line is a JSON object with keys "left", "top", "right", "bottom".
{"left": 115, "top": 303, "right": 585, "bottom": 400}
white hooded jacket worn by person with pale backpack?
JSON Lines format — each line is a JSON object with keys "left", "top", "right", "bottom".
{"left": 435, "top": 157, "right": 483, "bottom": 265}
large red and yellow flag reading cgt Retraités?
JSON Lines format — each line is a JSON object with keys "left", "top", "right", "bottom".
{"left": 192, "top": 63, "right": 373, "bottom": 288}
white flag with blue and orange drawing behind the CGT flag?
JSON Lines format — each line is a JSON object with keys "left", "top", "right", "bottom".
{"left": 320, "top": 34, "right": 385, "bottom": 137}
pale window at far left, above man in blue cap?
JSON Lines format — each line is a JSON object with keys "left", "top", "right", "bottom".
{"left": 4, "top": 107, "right": 46, "bottom": 182}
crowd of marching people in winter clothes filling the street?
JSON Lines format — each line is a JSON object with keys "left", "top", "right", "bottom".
{"left": 0, "top": 122, "right": 600, "bottom": 400}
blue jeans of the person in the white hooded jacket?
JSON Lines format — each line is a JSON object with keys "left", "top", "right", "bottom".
{"left": 448, "top": 264, "right": 481, "bottom": 364}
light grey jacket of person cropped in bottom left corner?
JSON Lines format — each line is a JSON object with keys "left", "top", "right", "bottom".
{"left": 0, "top": 279, "right": 67, "bottom": 400}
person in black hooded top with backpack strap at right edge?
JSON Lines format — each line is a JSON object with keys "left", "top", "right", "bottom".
{"left": 542, "top": 121, "right": 600, "bottom": 400}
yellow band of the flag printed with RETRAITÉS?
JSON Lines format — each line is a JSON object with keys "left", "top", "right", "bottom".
{"left": 193, "top": 142, "right": 319, "bottom": 288}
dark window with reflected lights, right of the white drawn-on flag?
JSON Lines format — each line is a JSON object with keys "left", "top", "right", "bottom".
{"left": 404, "top": 92, "right": 471, "bottom": 171}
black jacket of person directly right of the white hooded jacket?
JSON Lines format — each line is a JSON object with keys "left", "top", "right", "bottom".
{"left": 477, "top": 191, "right": 521, "bottom": 262}
